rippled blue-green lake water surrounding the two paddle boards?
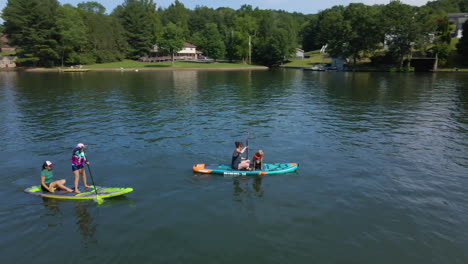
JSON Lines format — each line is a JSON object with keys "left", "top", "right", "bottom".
{"left": 0, "top": 70, "right": 468, "bottom": 264}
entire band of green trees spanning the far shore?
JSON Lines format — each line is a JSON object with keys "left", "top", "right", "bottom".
{"left": 1, "top": 0, "right": 468, "bottom": 67}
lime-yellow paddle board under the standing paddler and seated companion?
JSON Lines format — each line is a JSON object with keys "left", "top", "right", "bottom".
{"left": 24, "top": 185, "right": 133, "bottom": 200}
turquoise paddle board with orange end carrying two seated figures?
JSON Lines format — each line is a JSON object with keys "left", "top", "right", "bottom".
{"left": 193, "top": 163, "right": 299, "bottom": 175}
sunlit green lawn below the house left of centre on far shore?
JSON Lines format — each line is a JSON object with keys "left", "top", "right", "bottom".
{"left": 67, "top": 60, "right": 263, "bottom": 70}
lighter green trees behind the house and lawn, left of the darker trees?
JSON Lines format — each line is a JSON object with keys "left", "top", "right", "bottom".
{"left": 2, "top": 0, "right": 308, "bottom": 66}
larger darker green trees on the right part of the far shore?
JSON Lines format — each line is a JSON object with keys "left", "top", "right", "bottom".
{"left": 302, "top": 0, "right": 468, "bottom": 67}
